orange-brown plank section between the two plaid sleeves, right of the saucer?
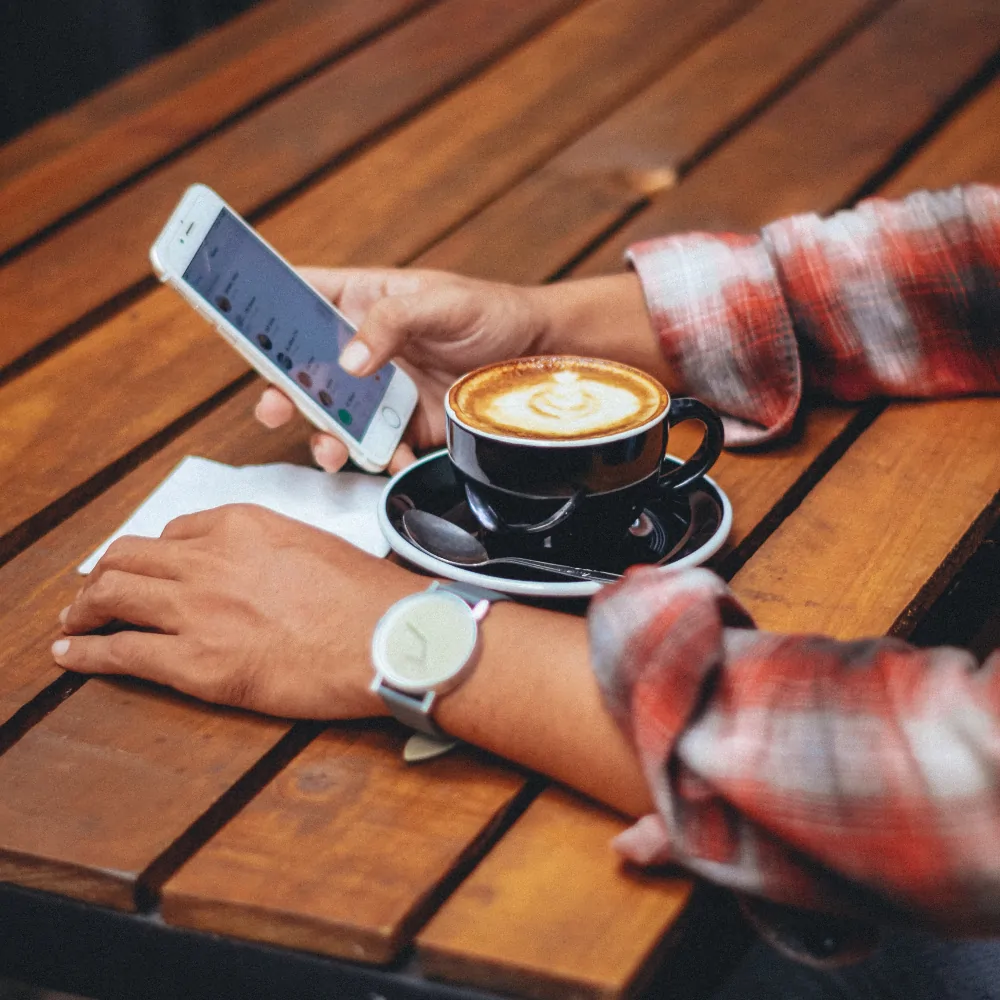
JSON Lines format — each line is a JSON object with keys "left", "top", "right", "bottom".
{"left": 733, "top": 399, "right": 1000, "bottom": 638}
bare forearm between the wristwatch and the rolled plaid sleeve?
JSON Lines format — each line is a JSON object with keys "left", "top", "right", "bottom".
{"left": 435, "top": 602, "right": 651, "bottom": 816}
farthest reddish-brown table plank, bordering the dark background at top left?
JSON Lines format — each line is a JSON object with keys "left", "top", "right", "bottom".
{"left": 0, "top": 0, "right": 422, "bottom": 253}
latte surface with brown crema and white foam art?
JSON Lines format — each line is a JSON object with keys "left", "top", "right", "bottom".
{"left": 448, "top": 356, "right": 669, "bottom": 441}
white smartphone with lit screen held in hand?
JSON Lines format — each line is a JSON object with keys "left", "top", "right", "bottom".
{"left": 149, "top": 184, "right": 417, "bottom": 472}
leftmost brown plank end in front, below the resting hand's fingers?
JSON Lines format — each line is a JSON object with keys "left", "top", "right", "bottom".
{"left": 0, "top": 679, "right": 287, "bottom": 910}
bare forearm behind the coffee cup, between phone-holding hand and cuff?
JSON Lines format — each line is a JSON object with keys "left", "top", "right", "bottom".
{"left": 528, "top": 271, "right": 677, "bottom": 398}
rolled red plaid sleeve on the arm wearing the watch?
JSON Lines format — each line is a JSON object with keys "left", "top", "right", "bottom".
{"left": 589, "top": 567, "right": 1000, "bottom": 933}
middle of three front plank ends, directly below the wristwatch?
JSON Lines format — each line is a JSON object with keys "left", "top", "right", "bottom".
{"left": 161, "top": 723, "right": 524, "bottom": 963}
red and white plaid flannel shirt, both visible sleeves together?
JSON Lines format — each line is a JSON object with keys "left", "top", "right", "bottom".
{"left": 589, "top": 186, "right": 1000, "bottom": 932}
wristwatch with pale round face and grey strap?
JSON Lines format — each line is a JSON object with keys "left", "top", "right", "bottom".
{"left": 371, "top": 581, "right": 510, "bottom": 759}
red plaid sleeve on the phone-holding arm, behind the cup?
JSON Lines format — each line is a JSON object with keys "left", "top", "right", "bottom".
{"left": 629, "top": 185, "right": 1000, "bottom": 446}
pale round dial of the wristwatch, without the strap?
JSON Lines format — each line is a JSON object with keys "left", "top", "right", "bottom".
{"left": 372, "top": 590, "right": 478, "bottom": 693}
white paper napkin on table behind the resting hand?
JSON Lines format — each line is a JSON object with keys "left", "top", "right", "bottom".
{"left": 79, "top": 456, "right": 389, "bottom": 573}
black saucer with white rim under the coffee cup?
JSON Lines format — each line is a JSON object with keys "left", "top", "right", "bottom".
{"left": 378, "top": 450, "right": 733, "bottom": 598}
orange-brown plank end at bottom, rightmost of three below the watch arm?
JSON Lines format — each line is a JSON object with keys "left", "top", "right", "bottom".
{"left": 416, "top": 789, "right": 692, "bottom": 1000}
